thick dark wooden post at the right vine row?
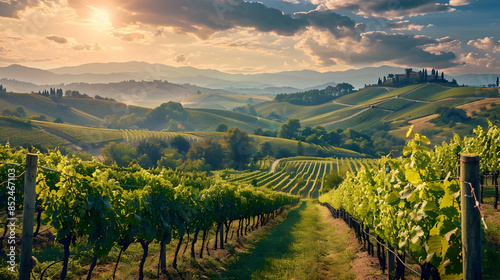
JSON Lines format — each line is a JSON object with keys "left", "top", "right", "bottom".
{"left": 460, "top": 154, "right": 481, "bottom": 280}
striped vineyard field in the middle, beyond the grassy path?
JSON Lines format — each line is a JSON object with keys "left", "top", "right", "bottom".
{"left": 223, "top": 157, "right": 376, "bottom": 198}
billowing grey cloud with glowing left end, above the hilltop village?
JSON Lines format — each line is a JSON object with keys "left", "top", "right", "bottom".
{"left": 296, "top": 32, "right": 457, "bottom": 69}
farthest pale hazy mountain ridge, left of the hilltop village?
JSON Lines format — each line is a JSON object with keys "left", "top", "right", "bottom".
{"left": 0, "top": 62, "right": 403, "bottom": 91}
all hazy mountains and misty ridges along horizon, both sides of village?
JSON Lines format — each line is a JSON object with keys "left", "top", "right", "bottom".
{"left": 0, "top": 61, "right": 500, "bottom": 107}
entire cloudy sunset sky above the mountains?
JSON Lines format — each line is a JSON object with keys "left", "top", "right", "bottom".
{"left": 0, "top": 0, "right": 500, "bottom": 75}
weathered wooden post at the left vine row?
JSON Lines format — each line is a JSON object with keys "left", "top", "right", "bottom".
{"left": 19, "top": 154, "right": 38, "bottom": 280}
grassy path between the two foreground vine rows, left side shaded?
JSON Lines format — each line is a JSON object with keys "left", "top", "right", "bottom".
{"left": 218, "top": 200, "right": 356, "bottom": 280}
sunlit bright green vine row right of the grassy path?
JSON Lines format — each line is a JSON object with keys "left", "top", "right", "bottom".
{"left": 319, "top": 123, "right": 500, "bottom": 279}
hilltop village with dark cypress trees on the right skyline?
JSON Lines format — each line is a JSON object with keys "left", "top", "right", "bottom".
{"left": 377, "top": 68, "right": 457, "bottom": 87}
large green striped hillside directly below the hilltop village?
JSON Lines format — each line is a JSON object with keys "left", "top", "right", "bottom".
{"left": 255, "top": 83, "right": 500, "bottom": 136}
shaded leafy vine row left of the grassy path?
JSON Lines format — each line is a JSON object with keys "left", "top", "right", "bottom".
{"left": 0, "top": 146, "right": 299, "bottom": 279}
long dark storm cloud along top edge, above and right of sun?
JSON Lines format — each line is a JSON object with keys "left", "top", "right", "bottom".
{"left": 68, "top": 0, "right": 355, "bottom": 39}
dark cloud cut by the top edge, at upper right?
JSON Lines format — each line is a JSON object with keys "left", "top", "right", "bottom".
{"left": 312, "top": 0, "right": 454, "bottom": 19}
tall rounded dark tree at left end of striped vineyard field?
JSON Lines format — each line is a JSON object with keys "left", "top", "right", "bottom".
{"left": 223, "top": 127, "right": 255, "bottom": 168}
